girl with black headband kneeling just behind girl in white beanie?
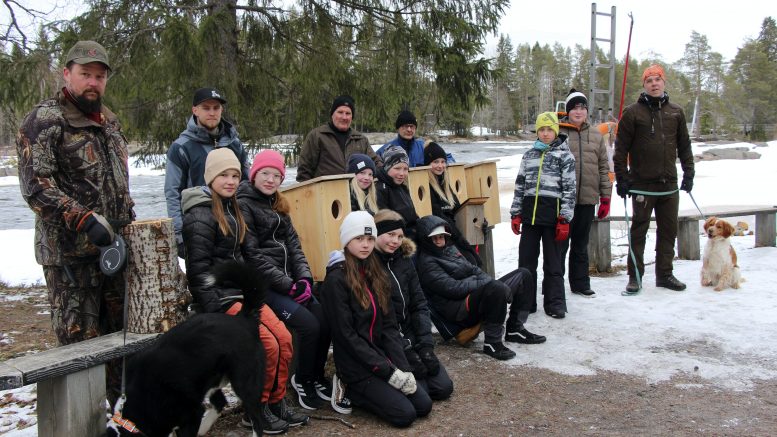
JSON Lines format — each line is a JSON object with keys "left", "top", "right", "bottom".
{"left": 375, "top": 209, "right": 453, "bottom": 400}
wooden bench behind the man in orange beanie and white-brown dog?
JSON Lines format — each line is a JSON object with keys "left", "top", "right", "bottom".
{"left": 588, "top": 205, "right": 777, "bottom": 272}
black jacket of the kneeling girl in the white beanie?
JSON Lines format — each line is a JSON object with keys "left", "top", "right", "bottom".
{"left": 321, "top": 254, "right": 411, "bottom": 384}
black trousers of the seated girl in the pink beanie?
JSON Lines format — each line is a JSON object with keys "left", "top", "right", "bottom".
{"left": 266, "top": 292, "right": 332, "bottom": 382}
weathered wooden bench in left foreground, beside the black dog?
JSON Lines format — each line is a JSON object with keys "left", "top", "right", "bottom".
{"left": 0, "top": 332, "right": 159, "bottom": 437}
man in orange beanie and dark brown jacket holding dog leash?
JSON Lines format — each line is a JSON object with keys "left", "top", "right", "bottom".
{"left": 613, "top": 64, "right": 694, "bottom": 294}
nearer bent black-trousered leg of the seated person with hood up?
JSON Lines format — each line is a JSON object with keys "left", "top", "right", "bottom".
{"left": 462, "top": 280, "right": 510, "bottom": 343}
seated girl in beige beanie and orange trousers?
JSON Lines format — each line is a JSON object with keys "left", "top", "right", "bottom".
{"left": 182, "top": 148, "right": 309, "bottom": 434}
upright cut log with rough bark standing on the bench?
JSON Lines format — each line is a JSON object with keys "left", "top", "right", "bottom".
{"left": 123, "top": 218, "right": 188, "bottom": 334}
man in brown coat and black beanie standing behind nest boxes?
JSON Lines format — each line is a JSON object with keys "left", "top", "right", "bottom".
{"left": 297, "top": 96, "right": 383, "bottom": 182}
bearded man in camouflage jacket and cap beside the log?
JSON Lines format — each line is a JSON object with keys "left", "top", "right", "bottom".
{"left": 16, "top": 41, "right": 134, "bottom": 345}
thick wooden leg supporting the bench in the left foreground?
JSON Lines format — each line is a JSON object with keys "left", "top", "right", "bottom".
{"left": 37, "top": 364, "right": 107, "bottom": 437}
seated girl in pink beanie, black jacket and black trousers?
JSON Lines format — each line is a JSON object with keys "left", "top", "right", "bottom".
{"left": 238, "top": 150, "right": 332, "bottom": 410}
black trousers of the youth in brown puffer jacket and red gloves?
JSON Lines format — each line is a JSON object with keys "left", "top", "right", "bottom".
{"left": 561, "top": 205, "right": 595, "bottom": 291}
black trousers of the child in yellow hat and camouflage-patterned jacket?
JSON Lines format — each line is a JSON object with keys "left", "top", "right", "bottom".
{"left": 518, "top": 225, "right": 567, "bottom": 312}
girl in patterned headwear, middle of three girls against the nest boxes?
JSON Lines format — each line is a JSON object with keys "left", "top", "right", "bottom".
{"left": 375, "top": 146, "right": 418, "bottom": 239}
